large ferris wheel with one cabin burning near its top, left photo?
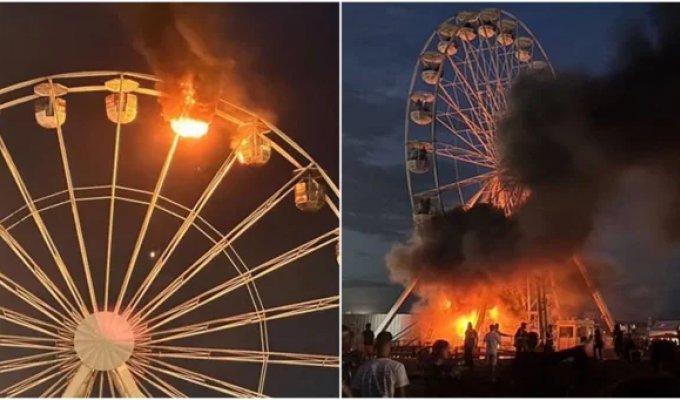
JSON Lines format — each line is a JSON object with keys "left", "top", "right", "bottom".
{"left": 0, "top": 71, "right": 339, "bottom": 397}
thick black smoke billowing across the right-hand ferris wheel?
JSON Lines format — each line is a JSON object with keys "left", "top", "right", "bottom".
{"left": 387, "top": 4, "right": 680, "bottom": 304}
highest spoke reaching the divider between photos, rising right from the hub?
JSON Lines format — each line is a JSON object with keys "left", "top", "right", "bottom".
{"left": 145, "top": 228, "right": 340, "bottom": 330}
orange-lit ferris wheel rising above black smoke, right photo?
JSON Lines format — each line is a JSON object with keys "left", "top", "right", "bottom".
{"left": 405, "top": 9, "right": 554, "bottom": 224}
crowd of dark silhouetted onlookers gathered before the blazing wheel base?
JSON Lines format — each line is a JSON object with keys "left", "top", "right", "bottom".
{"left": 342, "top": 323, "right": 677, "bottom": 397}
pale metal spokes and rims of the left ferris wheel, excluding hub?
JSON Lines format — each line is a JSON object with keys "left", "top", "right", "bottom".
{"left": 0, "top": 71, "right": 340, "bottom": 397}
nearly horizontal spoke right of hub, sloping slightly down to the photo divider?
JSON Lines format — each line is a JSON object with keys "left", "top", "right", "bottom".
{"left": 149, "top": 346, "right": 340, "bottom": 368}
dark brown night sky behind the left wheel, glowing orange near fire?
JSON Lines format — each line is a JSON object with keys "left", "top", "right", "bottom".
{"left": 0, "top": 4, "right": 339, "bottom": 397}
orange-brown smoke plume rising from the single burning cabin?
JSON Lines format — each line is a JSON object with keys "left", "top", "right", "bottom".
{"left": 121, "top": 3, "right": 275, "bottom": 122}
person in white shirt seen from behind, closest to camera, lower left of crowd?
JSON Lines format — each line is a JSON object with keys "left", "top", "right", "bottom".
{"left": 352, "top": 332, "right": 409, "bottom": 397}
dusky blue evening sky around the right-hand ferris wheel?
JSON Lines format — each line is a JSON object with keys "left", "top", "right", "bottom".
{"left": 343, "top": 3, "right": 680, "bottom": 319}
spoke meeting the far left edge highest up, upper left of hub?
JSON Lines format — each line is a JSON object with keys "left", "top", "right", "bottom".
{"left": 0, "top": 136, "right": 87, "bottom": 316}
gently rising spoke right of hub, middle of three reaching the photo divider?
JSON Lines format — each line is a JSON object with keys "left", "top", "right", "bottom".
{"left": 148, "top": 296, "right": 340, "bottom": 345}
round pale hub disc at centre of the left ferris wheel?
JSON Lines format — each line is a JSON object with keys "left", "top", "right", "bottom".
{"left": 73, "top": 311, "right": 135, "bottom": 371}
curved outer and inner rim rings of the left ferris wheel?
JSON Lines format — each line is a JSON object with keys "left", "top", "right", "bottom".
{"left": 0, "top": 71, "right": 339, "bottom": 394}
